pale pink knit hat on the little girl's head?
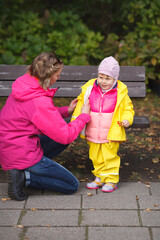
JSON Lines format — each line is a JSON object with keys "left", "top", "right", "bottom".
{"left": 98, "top": 56, "right": 120, "bottom": 81}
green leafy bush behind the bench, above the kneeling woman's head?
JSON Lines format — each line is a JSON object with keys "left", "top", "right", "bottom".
{"left": 0, "top": 10, "right": 103, "bottom": 65}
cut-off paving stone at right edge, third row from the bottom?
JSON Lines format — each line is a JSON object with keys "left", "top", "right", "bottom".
{"left": 139, "top": 195, "right": 160, "bottom": 210}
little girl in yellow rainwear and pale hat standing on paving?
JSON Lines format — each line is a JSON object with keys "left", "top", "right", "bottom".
{"left": 72, "top": 56, "right": 134, "bottom": 192}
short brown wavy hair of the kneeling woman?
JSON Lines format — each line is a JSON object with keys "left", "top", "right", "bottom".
{"left": 28, "top": 52, "right": 63, "bottom": 90}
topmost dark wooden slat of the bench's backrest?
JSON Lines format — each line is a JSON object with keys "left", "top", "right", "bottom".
{"left": 0, "top": 65, "right": 145, "bottom": 82}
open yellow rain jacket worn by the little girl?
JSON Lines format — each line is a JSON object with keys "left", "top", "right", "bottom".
{"left": 71, "top": 78, "right": 134, "bottom": 142}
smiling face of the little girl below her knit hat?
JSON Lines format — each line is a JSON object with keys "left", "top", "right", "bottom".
{"left": 97, "top": 73, "right": 115, "bottom": 90}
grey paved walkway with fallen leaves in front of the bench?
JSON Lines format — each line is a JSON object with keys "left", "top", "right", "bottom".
{"left": 0, "top": 182, "right": 160, "bottom": 240}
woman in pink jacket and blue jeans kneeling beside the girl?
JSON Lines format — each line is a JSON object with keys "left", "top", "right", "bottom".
{"left": 0, "top": 52, "right": 90, "bottom": 201}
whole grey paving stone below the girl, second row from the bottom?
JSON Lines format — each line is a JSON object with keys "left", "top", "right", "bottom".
{"left": 81, "top": 209, "right": 139, "bottom": 226}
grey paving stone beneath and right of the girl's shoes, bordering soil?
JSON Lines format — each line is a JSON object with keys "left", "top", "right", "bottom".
{"left": 98, "top": 182, "right": 149, "bottom": 196}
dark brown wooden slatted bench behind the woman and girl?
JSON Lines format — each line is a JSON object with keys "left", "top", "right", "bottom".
{"left": 0, "top": 65, "right": 150, "bottom": 128}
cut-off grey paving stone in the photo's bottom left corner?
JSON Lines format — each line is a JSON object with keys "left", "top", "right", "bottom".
{"left": 0, "top": 227, "right": 23, "bottom": 240}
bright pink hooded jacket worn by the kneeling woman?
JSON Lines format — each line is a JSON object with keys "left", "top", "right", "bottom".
{"left": 0, "top": 73, "right": 90, "bottom": 170}
